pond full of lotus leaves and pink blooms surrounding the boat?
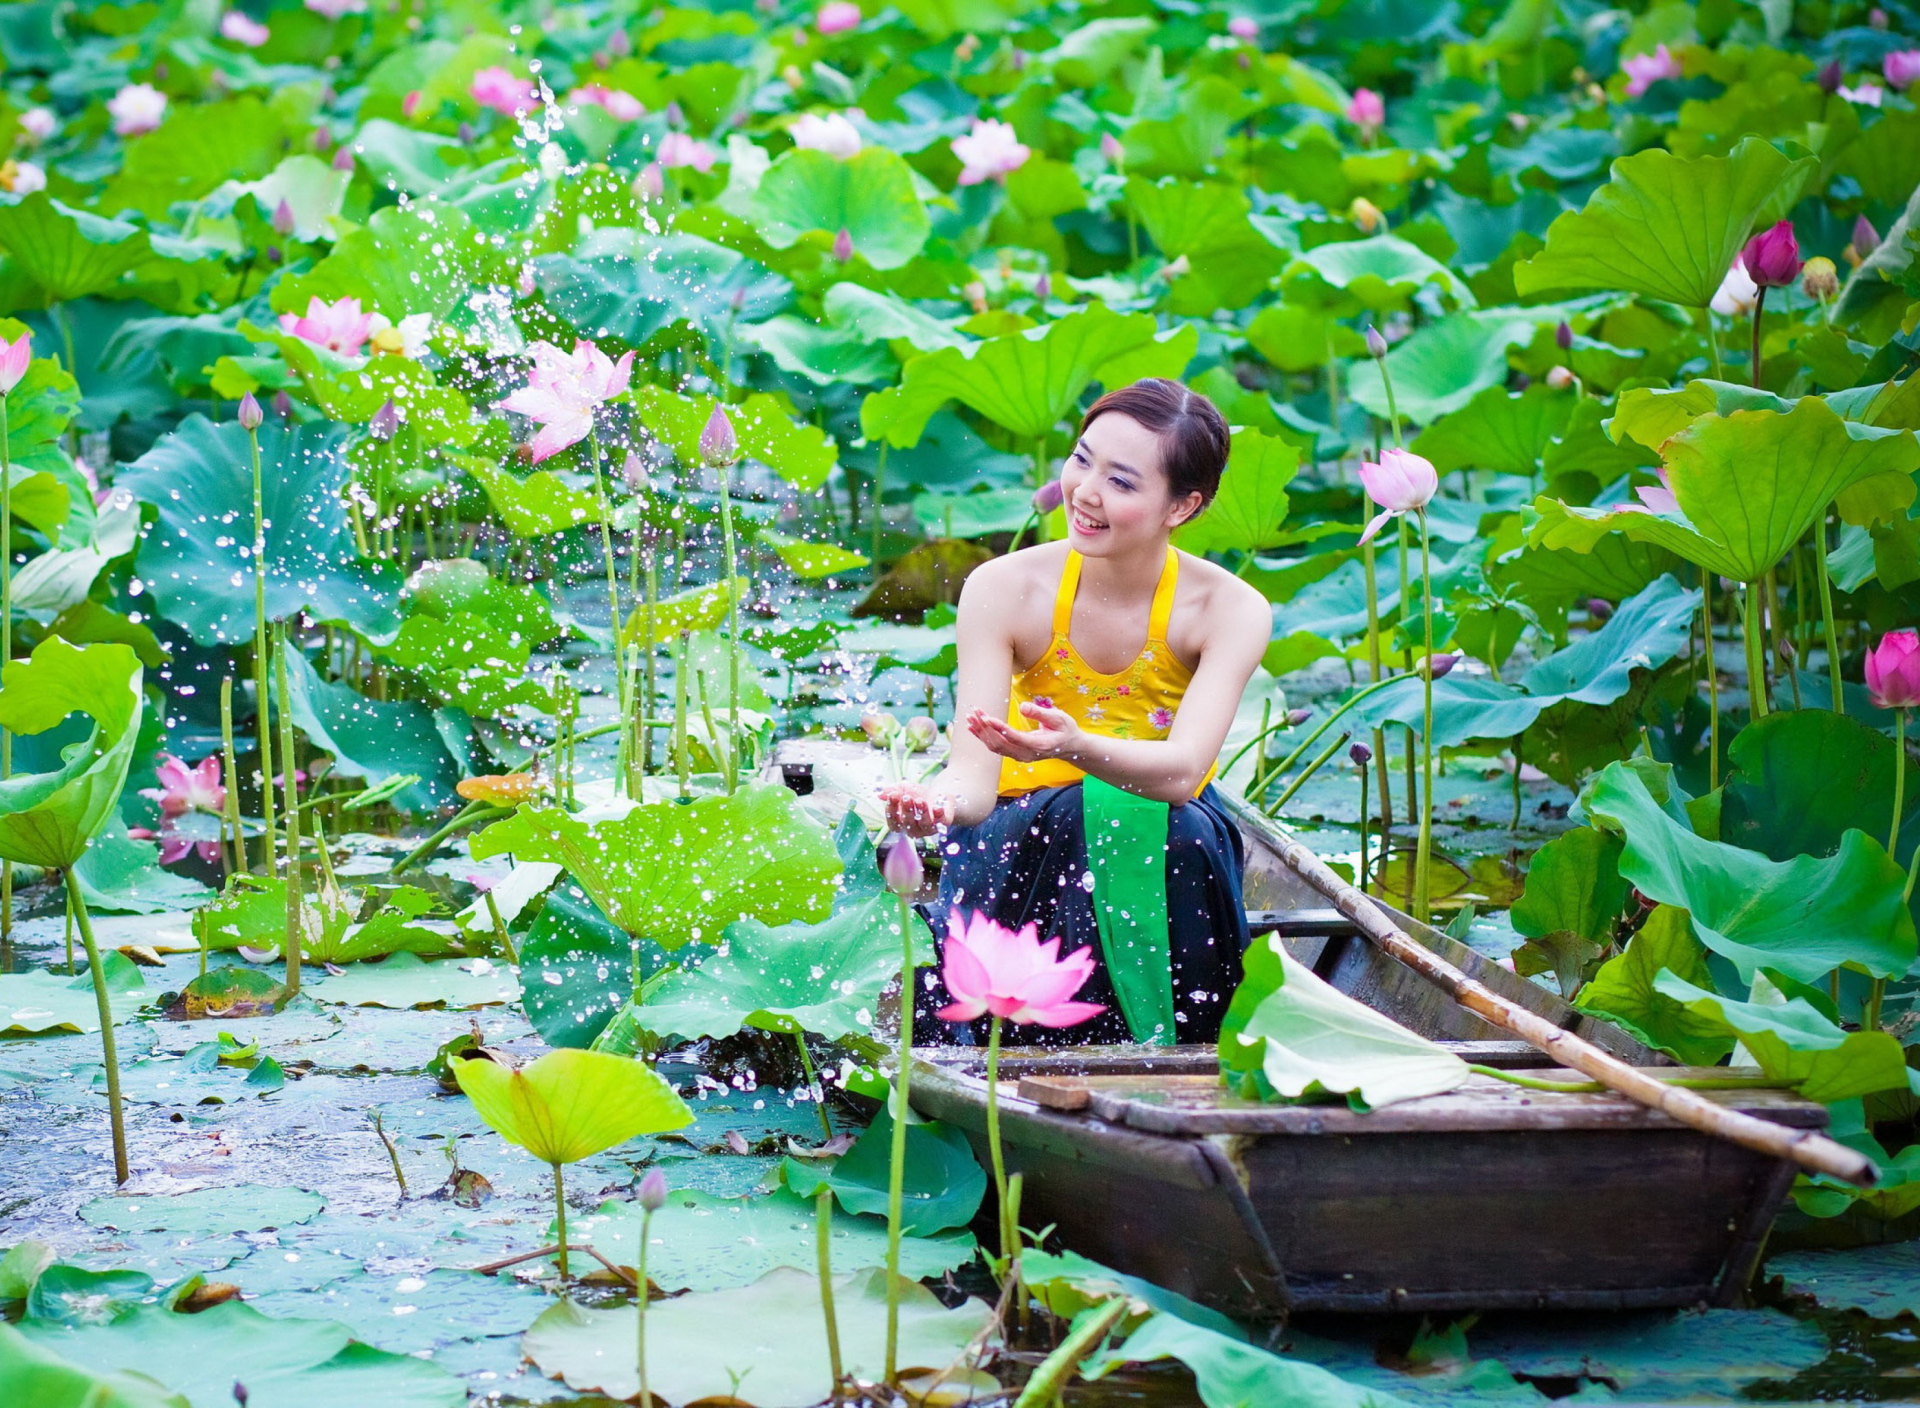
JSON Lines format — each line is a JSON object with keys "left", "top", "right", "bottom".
{"left": 0, "top": 0, "right": 1920, "bottom": 1408}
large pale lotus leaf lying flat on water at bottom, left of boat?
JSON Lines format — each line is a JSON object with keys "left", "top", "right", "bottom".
{"left": 520, "top": 1266, "right": 991, "bottom": 1408}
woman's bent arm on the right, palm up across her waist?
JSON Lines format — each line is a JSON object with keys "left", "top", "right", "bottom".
{"left": 954, "top": 582, "right": 1273, "bottom": 803}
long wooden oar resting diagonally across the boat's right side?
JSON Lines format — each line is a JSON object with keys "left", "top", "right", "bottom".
{"left": 1267, "top": 830, "right": 1878, "bottom": 1187}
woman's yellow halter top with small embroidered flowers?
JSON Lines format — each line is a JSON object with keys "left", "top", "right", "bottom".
{"left": 1000, "top": 547, "right": 1213, "bottom": 797}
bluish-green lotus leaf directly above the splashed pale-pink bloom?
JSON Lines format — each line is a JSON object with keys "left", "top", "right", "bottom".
{"left": 532, "top": 229, "right": 793, "bottom": 348}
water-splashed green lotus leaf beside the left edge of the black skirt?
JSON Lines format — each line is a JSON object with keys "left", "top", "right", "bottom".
{"left": 636, "top": 895, "right": 933, "bottom": 1041}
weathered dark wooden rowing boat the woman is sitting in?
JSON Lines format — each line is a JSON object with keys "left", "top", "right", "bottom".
{"left": 768, "top": 743, "right": 1826, "bottom": 1320}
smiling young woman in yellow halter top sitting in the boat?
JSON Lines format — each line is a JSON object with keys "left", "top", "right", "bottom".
{"left": 881, "top": 378, "right": 1271, "bottom": 1043}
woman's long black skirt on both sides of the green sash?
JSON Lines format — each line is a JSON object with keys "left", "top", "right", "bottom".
{"left": 914, "top": 782, "right": 1248, "bottom": 1047}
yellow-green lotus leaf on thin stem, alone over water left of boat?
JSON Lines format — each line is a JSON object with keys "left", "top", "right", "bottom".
{"left": 453, "top": 1047, "right": 693, "bottom": 1164}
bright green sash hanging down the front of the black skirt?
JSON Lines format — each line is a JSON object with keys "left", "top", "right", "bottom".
{"left": 1081, "top": 778, "right": 1175, "bottom": 1047}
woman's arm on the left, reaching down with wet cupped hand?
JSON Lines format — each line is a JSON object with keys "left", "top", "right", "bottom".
{"left": 879, "top": 559, "right": 1018, "bottom": 836}
